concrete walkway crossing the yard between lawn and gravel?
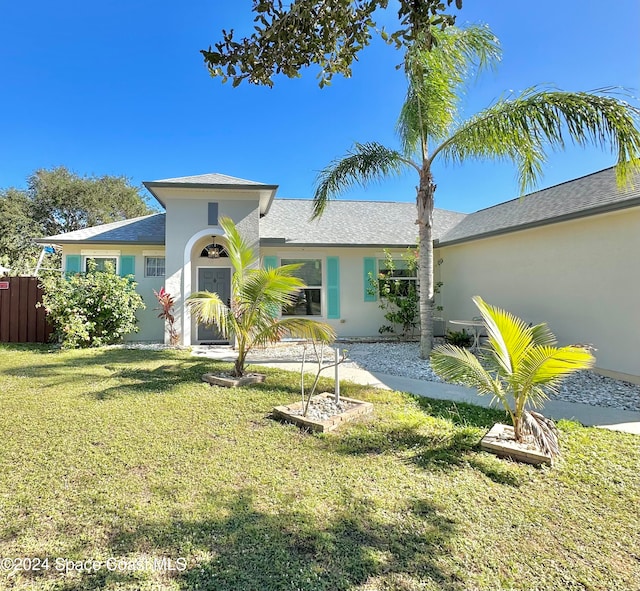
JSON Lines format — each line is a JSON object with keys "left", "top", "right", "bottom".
{"left": 193, "top": 348, "right": 640, "bottom": 435}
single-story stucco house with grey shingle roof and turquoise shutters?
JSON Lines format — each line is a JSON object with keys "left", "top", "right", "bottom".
{"left": 40, "top": 168, "right": 640, "bottom": 377}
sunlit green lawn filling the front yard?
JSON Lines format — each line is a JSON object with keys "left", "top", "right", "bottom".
{"left": 0, "top": 346, "right": 640, "bottom": 591}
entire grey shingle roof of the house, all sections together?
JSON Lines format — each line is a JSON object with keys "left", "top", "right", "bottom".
{"left": 37, "top": 168, "right": 640, "bottom": 247}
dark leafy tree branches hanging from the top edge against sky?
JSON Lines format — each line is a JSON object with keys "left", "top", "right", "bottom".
{"left": 201, "top": 0, "right": 462, "bottom": 87}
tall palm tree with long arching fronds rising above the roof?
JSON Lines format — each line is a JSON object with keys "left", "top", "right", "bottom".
{"left": 313, "top": 26, "right": 640, "bottom": 358}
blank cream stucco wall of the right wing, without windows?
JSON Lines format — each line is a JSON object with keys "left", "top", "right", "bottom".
{"left": 439, "top": 207, "right": 640, "bottom": 376}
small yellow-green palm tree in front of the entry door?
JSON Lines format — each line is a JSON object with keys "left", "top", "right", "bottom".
{"left": 187, "top": 218, "right": 335, "bottom": 377}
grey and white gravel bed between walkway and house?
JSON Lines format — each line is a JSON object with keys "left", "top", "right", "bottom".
{"left": 251, "top": 342, "right": 640, "bottom": 412}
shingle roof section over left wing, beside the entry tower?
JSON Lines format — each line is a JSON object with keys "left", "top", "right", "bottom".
{"left": 36, "top": 213, "right": 165, "bottom": 244}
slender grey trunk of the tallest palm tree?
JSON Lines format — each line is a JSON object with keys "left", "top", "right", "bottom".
{"left": 416, "top": 162, "right": 436, "bottom": 359}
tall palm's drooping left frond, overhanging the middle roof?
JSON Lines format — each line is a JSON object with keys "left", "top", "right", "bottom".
{"left": 311, "top": 142, "right": 420, "bottom": 219}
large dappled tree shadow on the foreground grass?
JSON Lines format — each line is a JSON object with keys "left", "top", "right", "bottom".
{"left": 46, "top": 490, "right": 462, "bottom": 591}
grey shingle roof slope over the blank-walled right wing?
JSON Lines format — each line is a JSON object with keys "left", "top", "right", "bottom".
{"left": 440, "top": 168, "right": 640, "bottom": 245}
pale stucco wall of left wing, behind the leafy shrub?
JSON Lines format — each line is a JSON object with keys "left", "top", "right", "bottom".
{"left": 62, "top": 244, "right": 164, "bottom": 342}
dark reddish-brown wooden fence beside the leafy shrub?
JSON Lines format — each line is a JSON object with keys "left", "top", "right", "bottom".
{"left": 0, "top": 277, "right": 51, "bottom": 343}
